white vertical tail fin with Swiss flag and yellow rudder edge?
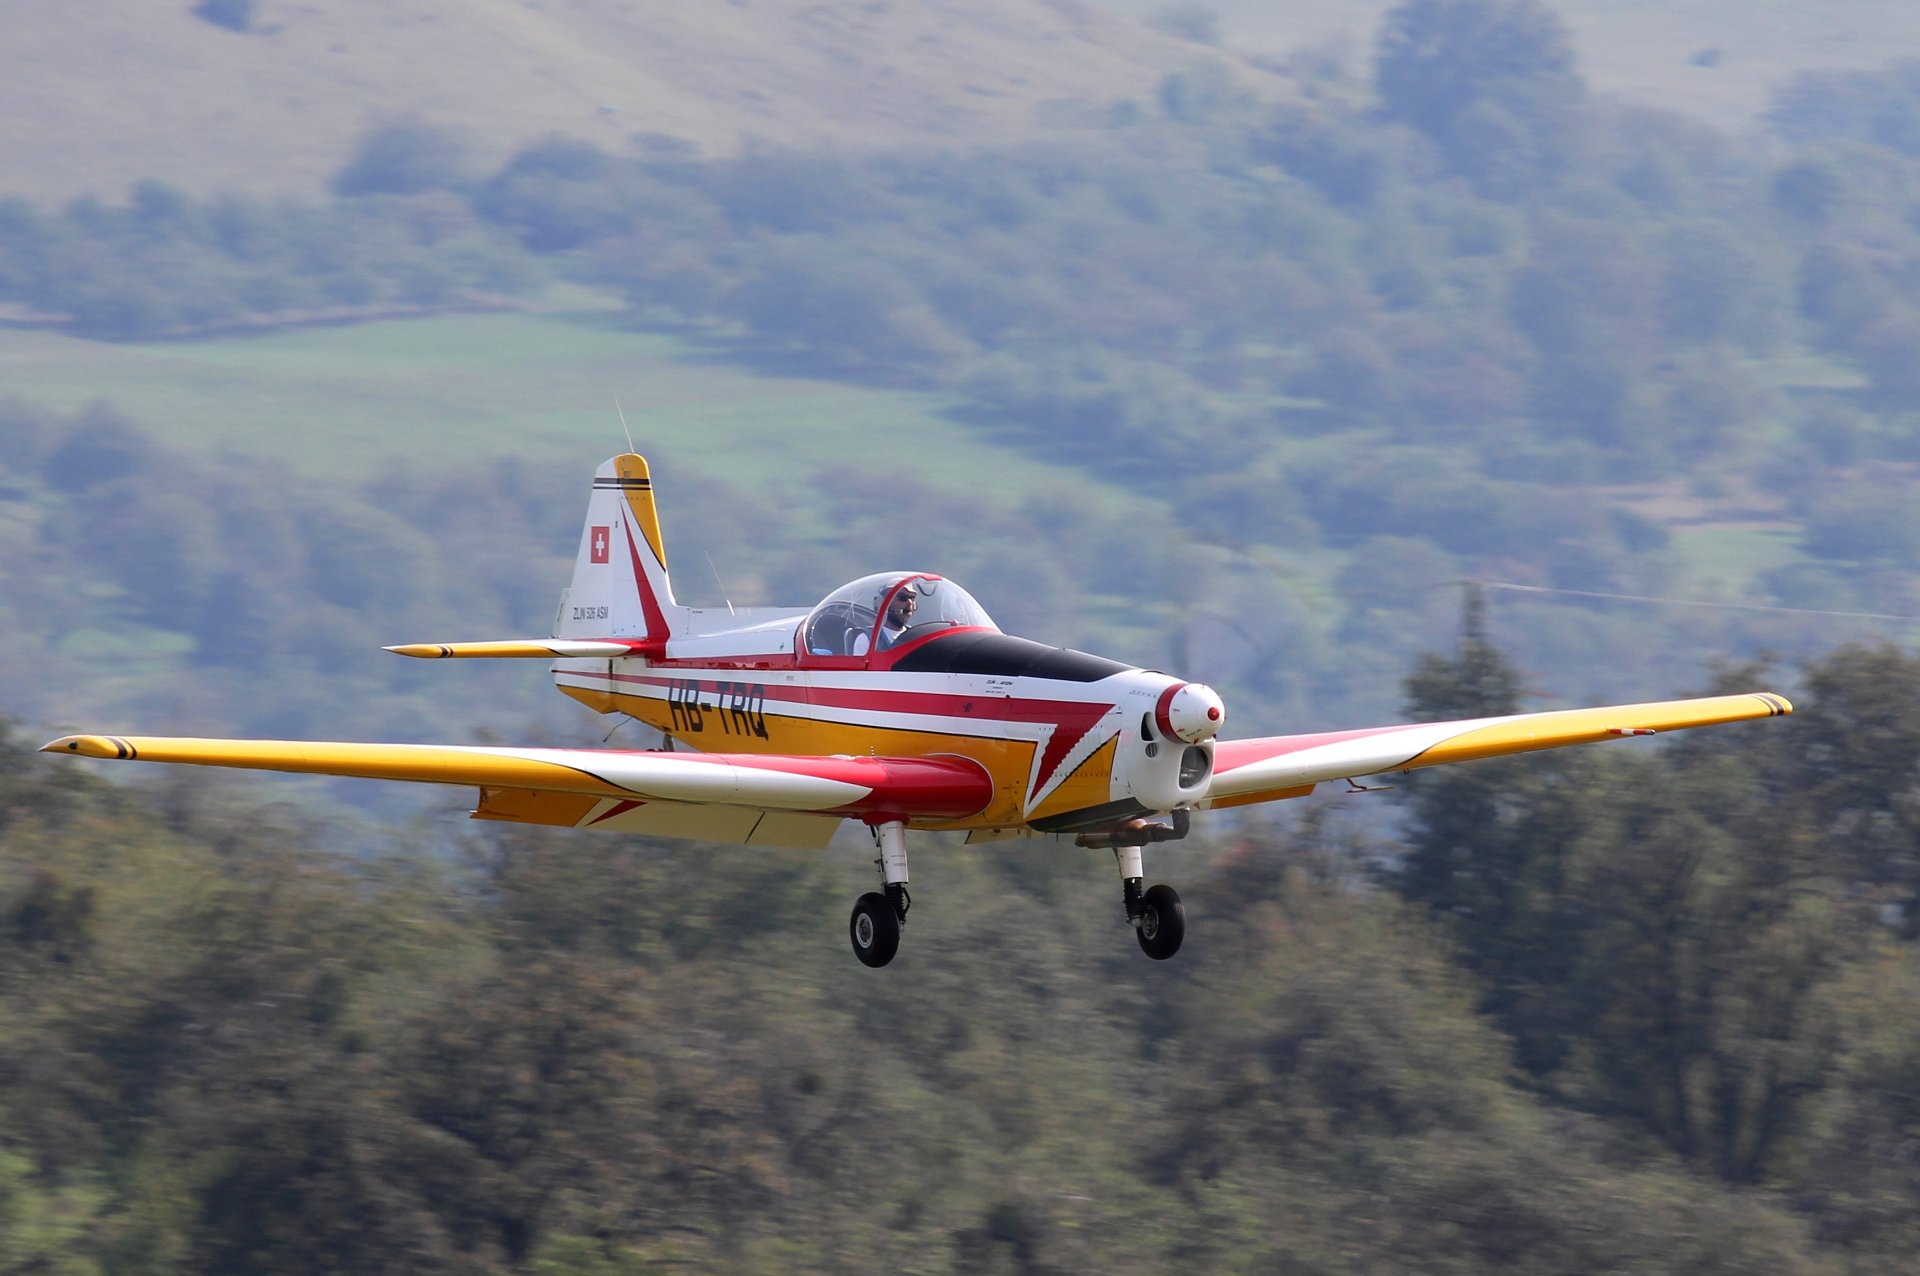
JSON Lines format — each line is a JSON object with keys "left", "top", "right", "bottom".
{"left": 553, "top": 453, "right": 684, "bottom": 645}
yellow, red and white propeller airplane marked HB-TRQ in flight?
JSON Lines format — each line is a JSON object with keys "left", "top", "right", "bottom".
{"left": 44, "top": 453, "right": 1793, "bottom": 965}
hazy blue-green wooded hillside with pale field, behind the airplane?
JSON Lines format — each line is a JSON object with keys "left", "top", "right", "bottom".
{"left": 15, "top": 0, "right": 1920, "bottom": 748}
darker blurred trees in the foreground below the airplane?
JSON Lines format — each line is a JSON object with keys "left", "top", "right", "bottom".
{"left": 11, "top": 627, "right": 1920, "bottom": 1274}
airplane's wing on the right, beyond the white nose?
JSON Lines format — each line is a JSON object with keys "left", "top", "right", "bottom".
{"left": 1204, "top": 691, "right": 1793, "bottom": 806}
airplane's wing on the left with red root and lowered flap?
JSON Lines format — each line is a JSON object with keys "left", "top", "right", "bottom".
{"left": 40, "top": 735, "right": 993, "bottom": 848}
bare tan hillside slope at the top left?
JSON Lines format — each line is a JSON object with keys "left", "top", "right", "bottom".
{"left": 0, "top": 0, "right": 1251, "bottom": 200}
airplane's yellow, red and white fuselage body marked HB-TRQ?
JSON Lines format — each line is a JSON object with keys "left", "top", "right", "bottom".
{"left": 555, "top": 629, "right": 1212, "bottom": 833}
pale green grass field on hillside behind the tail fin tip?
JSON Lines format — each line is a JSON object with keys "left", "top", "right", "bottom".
{"left": 0, "top": 309, "right": 1123, "bottom": 501}
